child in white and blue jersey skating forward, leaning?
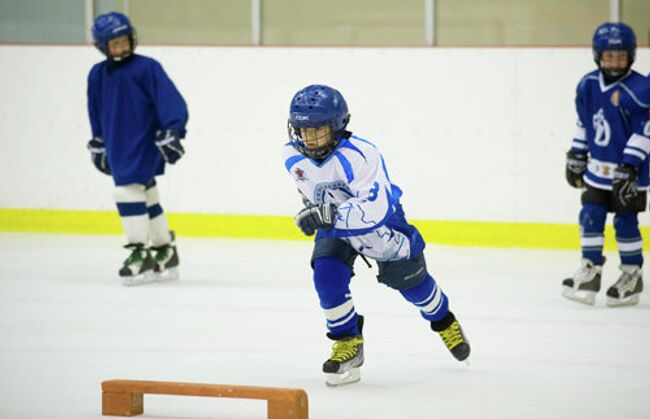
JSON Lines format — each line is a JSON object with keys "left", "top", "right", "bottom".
{"left": 284, "top": 85, "right": 470, "bottom": 385}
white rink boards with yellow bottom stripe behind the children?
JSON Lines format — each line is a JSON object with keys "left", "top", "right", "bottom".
{"left": 0, "top": 45, "right": 650, "bottom": 249}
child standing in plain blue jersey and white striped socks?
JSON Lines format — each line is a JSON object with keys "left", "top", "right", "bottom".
{"left": 88, "top": 12, "right": 188, "bottom": 285}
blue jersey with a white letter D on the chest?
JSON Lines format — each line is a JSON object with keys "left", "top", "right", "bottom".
{"left": 571, "top": 70, "right": 650, "bottom": 190}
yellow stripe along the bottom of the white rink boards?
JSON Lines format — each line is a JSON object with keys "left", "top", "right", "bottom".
{"left": 0, "top": 209, "right": 650, "bottom": 251}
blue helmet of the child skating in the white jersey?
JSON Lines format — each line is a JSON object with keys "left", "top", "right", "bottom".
{"left": 288, "top": 84, "right": 350, "bottom": 159}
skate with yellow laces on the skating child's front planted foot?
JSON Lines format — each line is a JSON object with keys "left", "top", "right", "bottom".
{"left": 323, "top": 316, "right": 363, "bottom": 386}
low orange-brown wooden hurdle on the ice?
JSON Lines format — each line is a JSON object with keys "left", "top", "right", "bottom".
{"left": 102, "top": 380, "right": 309, "bottom": 419}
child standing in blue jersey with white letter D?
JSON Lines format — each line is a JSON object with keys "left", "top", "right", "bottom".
{"left": 562, "top": 23, "right": 650, "bottom": 306}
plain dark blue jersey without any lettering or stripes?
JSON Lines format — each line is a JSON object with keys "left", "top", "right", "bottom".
{"left": 88, "top": 55, "right": 188, "bottom": 185}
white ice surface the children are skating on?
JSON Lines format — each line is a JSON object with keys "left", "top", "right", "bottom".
{"left": 0, "top": 233, "right": 650, "bottom": 419}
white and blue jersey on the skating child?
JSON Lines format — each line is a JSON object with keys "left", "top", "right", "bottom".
{"left": 284, "top": 135, "right": 424, "bottom": 261}
